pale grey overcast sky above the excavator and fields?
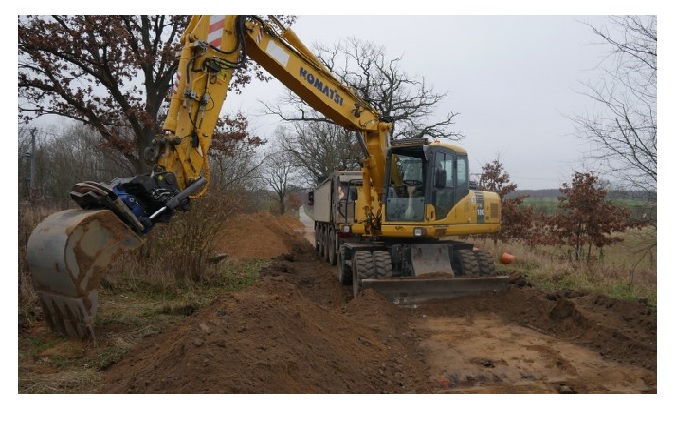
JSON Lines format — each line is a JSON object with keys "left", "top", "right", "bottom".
{"left": 225, "top": 15, "right": 624, "bottom": 189}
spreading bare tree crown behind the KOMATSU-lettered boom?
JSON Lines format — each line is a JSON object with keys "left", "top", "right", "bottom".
{"left": 264, "top": 38, "right": 463, "bottom": 183}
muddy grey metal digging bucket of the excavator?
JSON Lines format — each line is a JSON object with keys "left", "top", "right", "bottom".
{"left": 27, "top": 210, "right": 143, "bottom": 338}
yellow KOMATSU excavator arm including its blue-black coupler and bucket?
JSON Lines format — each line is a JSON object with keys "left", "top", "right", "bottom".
{"left": 27, "top": 15, "right": 391, "bottom": 338}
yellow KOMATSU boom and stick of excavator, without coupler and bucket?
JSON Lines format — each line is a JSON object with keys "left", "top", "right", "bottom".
{"left": 154, "top": 15, "right": 391, "bottom": 209}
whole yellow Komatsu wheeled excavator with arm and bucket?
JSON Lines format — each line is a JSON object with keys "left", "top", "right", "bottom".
{"left": 27, "top": 15, "right": 505, "bottom": 338}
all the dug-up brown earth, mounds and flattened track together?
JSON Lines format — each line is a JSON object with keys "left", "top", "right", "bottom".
{"left": 102, "top": 213, "right": 657, "bottom": 394}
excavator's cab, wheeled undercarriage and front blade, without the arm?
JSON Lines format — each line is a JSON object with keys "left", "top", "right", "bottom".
{"left": 338, "top": 139, "right": 507, "bottom": 305}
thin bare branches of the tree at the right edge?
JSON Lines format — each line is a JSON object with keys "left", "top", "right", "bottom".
{"left": 574, "top": 16, "right": 658, "bottom": 192}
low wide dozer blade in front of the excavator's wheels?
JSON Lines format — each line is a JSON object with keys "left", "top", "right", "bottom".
{"left": 361, "top": 276, "right": 509, "bottom": 305}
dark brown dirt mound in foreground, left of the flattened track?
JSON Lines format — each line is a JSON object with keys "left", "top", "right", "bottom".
{"left": 104, "top": 238, "right": 428, "bottom": 393}
